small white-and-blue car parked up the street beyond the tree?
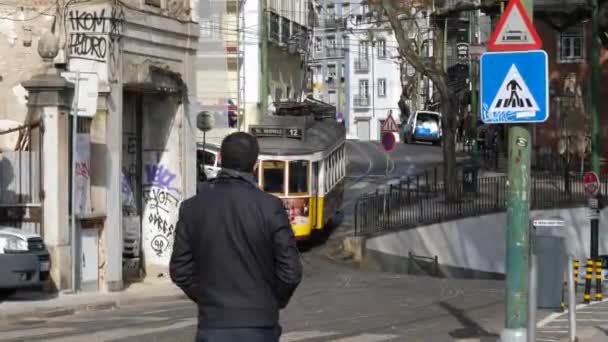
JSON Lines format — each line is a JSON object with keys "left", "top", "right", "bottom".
{"left": 403, "top": 111, "right": 442, "bottom": 145}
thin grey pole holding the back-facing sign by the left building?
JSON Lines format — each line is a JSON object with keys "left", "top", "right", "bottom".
{"left": 70, "top": 71, "right": 80, "bottom": 292}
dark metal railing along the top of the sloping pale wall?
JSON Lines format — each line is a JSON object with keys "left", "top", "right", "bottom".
{"left": 354, "top": 170, "right": 608, "bottom": 236}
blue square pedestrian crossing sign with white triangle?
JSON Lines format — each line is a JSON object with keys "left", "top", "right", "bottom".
{"left": 480, "top": 50, "right": 549, "bottom": 124}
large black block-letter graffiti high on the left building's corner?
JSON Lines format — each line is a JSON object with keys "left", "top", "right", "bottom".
{"left": 66, "top": 6, "right": 124, "bottom": 62}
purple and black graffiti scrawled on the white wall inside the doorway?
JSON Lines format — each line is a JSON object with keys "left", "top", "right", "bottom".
{"left": 143, "top": 163, "right": 181, "bottom": 258}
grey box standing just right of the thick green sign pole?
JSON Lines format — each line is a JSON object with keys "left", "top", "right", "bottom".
{"left": 532, "top": 223, "right": 567, "bottom": 309}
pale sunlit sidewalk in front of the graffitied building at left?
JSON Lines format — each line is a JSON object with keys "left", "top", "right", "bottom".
{"left": 0, "top": 278, "right": 186, "bottom": 320}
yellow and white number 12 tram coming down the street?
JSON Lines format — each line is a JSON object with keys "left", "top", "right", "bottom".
{"left": 198, "top": 111, "right": 346, "bottom": 240}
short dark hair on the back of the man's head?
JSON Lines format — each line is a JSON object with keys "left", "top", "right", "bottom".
{"left": 220, "top": 132, "right": 260, "bottom": 172}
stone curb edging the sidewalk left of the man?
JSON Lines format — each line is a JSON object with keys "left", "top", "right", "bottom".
{"left": 0, "top": 293, "right": 188, "bottom": 320}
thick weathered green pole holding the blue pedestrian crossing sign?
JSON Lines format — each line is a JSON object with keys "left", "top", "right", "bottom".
{"left": 502, "top": 0, "right": 534, "bottom": 341}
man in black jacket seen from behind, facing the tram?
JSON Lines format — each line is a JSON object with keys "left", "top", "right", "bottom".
{"left": 170, "top": 132, "right": 302, "bottom": 342}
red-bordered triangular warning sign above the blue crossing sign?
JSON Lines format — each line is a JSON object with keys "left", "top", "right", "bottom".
{"left": 488, "top": 0, "right": 543, "bottom": 51}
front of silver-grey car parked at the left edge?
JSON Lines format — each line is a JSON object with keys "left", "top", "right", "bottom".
{"left": 0, "top": 227, "right": 51, "bottom": 298}
